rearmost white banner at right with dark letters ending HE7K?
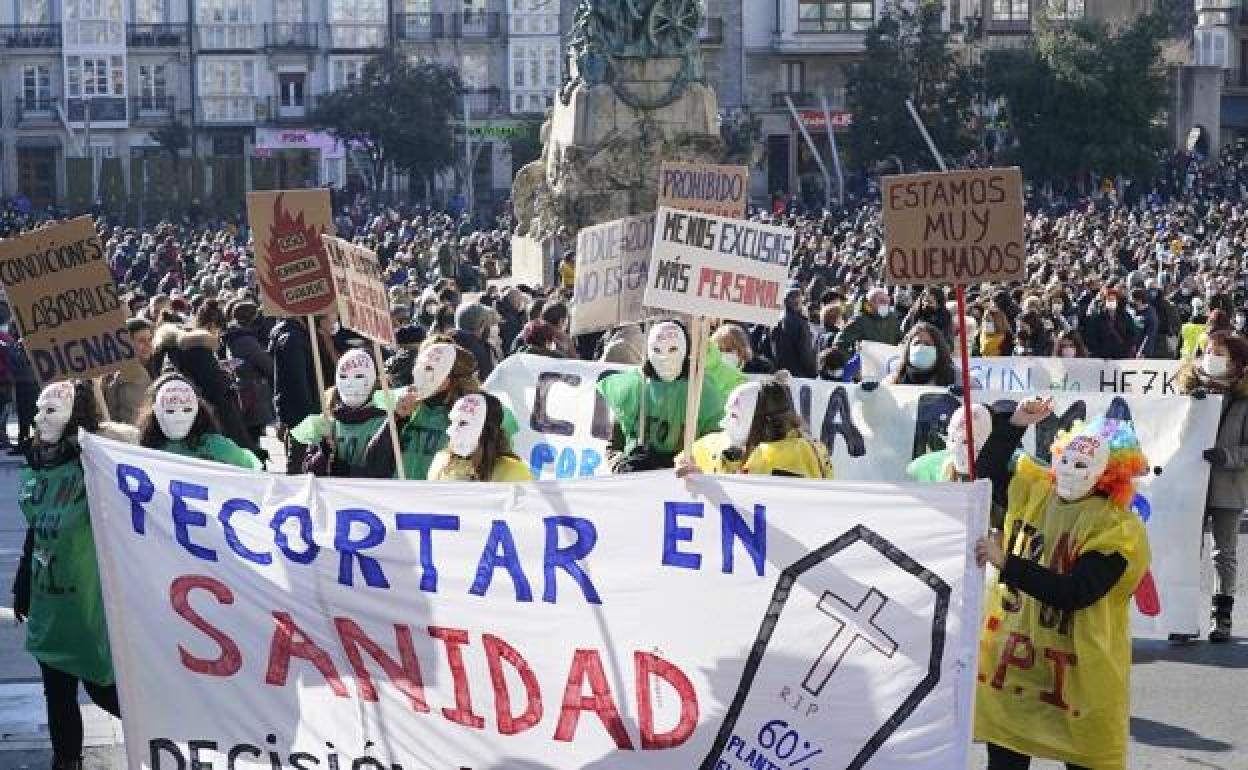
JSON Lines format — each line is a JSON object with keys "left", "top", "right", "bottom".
{"left": 859, "top": 342, "right": 1183, "bottom": 396}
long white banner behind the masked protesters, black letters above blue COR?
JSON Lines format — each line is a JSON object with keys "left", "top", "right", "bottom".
{"left": 487, "top": 356, "right": 1221, "bottom": 635}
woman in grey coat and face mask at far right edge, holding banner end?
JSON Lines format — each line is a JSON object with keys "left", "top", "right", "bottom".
{"left": 1178, "top": 331, "right": 1248, "bottom": 644}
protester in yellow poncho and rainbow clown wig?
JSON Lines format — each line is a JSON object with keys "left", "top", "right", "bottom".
{"left": 975, "top": 399, "right": 1151, "bottom": 770}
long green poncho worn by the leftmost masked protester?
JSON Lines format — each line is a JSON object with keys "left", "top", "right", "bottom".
{"left": 17, "top": 461, "right": 114, "bottom": 685}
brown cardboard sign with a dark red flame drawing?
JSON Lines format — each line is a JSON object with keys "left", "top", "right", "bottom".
{"left": 247, "top": 190, "right": 334, "bottom": 316}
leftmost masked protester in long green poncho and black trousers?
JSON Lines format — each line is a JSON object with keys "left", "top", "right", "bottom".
{"left": 12, "top": 381, "right": 120, "bottom": 770}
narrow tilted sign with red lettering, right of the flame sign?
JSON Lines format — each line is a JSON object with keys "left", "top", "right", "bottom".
{"left": 321, "top": 236, "right": 394, "bottom": 344}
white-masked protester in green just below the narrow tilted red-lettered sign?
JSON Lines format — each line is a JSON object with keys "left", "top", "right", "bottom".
{"left": 291, "top": 349, "right": 391, "bottom": 478}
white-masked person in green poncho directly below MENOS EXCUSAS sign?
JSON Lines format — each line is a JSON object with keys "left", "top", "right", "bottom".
{"left": 598, "top": 321, "right": 736, "bottom": 473}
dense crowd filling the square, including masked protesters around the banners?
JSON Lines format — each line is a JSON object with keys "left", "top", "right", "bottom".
{"left": 0, "top": 145, "right": 1248, "bottom": 770}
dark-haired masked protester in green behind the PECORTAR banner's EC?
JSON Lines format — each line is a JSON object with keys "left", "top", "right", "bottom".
{"left": 139, "top": 373, "right": 263, "bottom": 470}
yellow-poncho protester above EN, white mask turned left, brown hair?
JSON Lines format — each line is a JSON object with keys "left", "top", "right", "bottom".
{"left": 676, "top": 371, "right": 832, "bottom": 478}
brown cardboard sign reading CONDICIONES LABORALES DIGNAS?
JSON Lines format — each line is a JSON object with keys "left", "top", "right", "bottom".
{"left": 0, "top": 217, "right": 141, "bottom": 384}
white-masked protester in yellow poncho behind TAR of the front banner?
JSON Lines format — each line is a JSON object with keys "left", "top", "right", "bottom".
{"left": 429, "top": 392, "right": 533, "bottom": 482}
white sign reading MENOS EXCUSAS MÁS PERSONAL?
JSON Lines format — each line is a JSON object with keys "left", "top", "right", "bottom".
{"left": 644, "top": 208, "right": 796, "bottom": 326}
